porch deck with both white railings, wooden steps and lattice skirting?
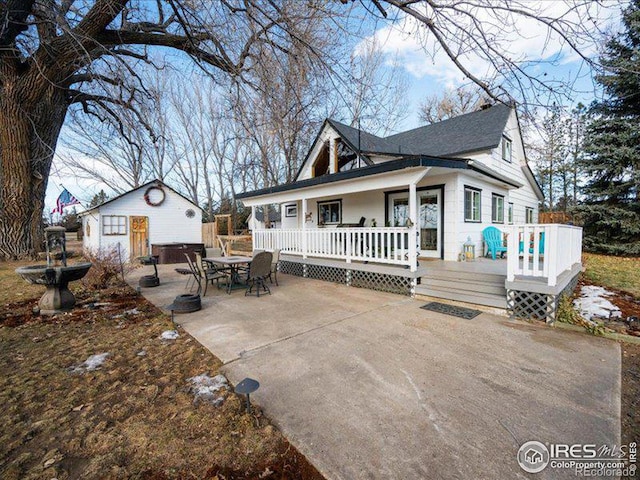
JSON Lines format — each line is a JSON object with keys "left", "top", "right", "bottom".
{"left": 253, "top": 224, "right": 582, "bottom": 321}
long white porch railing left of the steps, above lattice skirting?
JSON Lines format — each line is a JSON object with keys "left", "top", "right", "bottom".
{"left": 253, "top": 227, "right": 415, "bottom": 265}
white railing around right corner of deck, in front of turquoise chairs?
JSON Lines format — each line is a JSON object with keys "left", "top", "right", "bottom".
{"left": 507, "top": 224, "right": 582, "bottom": 287}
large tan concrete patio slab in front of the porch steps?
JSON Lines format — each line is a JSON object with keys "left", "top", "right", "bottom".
{"left": 132, "top": 266, "right": 620, "bottom": 479}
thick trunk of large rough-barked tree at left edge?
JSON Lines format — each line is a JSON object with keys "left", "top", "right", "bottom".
{"left": 0, "top": 81, "right": 68, "bottom": 259}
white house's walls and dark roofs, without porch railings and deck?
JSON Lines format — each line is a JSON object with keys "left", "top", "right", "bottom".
{"left": 238, "top": 105, "right": 543, "bottom": 261}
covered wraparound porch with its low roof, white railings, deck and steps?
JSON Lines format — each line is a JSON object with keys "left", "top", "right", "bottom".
{"left": 239, "top": 157, "right": 582, "bottom": 319}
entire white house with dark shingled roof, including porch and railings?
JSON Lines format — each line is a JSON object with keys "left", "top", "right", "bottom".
{"left": 237, "top": 104, "right": 581, "bottom": 315}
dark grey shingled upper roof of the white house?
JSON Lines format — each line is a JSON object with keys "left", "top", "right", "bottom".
{"left": 329, "top": 104, "right": 511, "bottom": 157}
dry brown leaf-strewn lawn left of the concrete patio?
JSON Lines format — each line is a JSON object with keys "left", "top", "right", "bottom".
{"left": 0, "top": 263, "right": 322, "bottom": 480}
